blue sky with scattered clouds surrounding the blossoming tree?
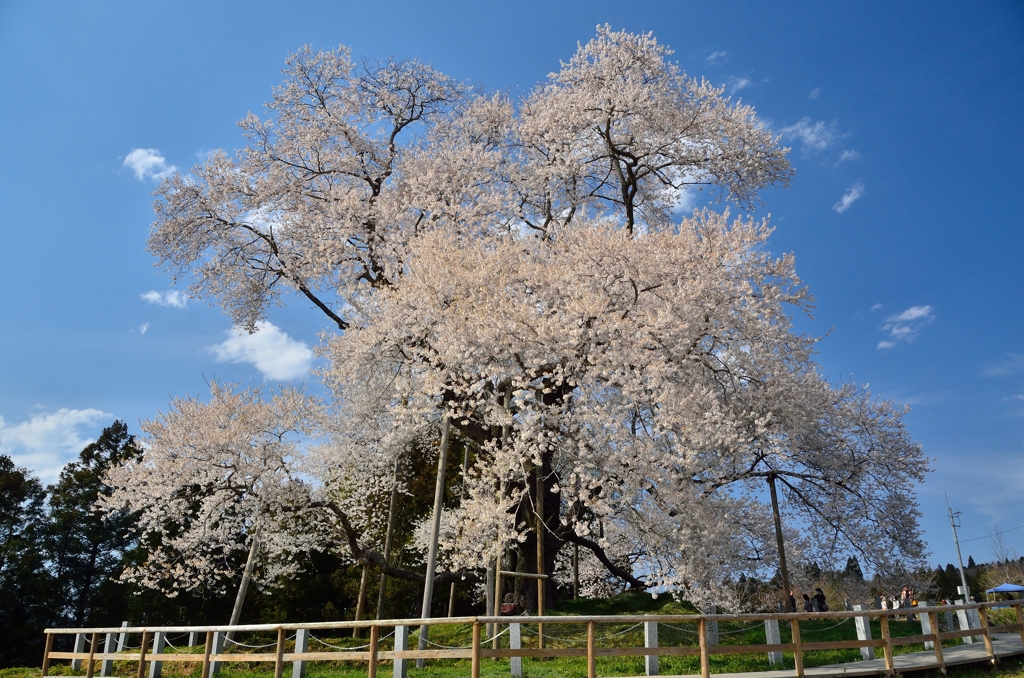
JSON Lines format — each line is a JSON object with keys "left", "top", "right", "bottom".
{"left": 0, "top": 0, "right": 1024, "bottom": 563}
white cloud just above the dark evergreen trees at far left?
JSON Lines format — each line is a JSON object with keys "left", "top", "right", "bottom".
{"left": 0, "top": 408, "right": 114, "bottom": 482}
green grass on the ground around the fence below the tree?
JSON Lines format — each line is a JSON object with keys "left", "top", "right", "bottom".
{"left": 22, "top": 594, "right": 1024, "bottom": 678}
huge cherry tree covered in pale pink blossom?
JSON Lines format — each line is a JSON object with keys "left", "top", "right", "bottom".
{"left": 128, "top": 27, "right": 927, "bottom": 603}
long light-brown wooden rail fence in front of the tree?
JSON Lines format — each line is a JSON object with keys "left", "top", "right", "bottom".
{"left": 42, "top": 600, "right": 1024, "bottom": 678}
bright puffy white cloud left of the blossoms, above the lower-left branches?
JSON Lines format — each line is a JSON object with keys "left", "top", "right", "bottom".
{"left": 210, "top": 321, "right": 313, "bottom": 381}
